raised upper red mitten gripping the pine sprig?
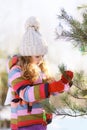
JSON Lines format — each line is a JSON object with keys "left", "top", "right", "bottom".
{"left": 61, "top": 70, "right": 73, "bottom": 84}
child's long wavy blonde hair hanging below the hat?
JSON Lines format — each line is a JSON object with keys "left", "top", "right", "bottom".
{"left": 19, "top": 56, "right": 51, "bottom": 83}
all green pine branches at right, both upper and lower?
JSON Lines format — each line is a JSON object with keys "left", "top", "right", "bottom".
{"left": 43, "top": 9, "right": 87, "bottom": 117}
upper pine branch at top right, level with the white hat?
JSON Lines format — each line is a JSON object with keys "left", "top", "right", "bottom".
{"left": 56, "top": 9, "right": 87, "bottom": 52}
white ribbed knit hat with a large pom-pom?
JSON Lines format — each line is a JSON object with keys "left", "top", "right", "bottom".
{"left": 19, "top": 16, "right": 48, "bottom": 56}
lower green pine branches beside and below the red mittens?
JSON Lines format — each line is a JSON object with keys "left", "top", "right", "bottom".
{"left": 42, "top": 64, "right": 87, "bottom": 117}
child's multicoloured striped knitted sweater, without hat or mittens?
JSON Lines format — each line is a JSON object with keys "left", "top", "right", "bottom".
{"left": 8, "top": 57, "right": 69, "bottom": 130}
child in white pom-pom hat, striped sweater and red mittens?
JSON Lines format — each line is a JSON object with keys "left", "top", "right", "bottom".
{"left": 5, "top": 17, "right": 73, "bottom": 130}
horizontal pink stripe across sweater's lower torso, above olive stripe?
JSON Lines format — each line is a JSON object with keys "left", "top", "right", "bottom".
{"left": 17, "top": 108, "right": 43, "bottom": 116}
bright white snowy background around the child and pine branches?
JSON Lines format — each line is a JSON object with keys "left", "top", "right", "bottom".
{"left": 0, "top": 0, "right": 87, "bottom": 130}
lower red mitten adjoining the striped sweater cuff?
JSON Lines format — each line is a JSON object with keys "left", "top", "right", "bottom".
{"left": 48, "top": 80, "right": 65, "bottom": 93}
